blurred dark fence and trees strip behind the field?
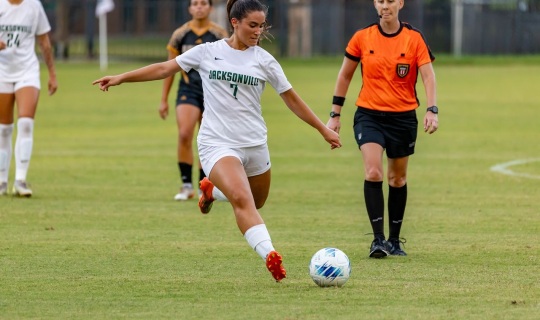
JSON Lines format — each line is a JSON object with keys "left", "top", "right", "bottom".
{"left": 42, "top": 0, "right": 540, "bottom": 60}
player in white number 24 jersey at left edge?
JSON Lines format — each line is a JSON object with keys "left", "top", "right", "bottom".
{"left": 0, "top": 0, "right": 58, "bottom": 197}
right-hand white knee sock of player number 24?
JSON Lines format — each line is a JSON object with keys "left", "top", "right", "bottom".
{"left": 15, "top": 118, "right": 34, "bottom": 181}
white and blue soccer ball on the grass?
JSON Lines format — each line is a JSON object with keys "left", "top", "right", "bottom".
{"left": 309, "top": 248, "right": 351, "bottom": 287}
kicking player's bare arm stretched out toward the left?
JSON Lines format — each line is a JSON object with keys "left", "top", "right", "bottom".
{"left": 92, "top": 59, "right": 182, "bottom": 91}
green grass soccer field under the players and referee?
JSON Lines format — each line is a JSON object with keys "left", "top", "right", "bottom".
{"left": 0, "top": 58, "right": 540, "bottom": 319}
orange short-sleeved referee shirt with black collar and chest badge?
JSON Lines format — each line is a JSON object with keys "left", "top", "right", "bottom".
{"left": 345, "top": 22, "right": 435, "bottom": 112}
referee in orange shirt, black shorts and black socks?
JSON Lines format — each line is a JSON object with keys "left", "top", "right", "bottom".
{"left": 327, "top": 0, "right": 439, "bottom": 258}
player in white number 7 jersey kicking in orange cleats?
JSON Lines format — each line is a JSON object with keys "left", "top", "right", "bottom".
{"left": 93, "top": 0, "right": 341, "bottom": 281}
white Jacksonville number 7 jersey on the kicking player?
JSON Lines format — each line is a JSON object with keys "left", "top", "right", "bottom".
{"left": 176, "top": 39, "right": 292, "bottom": 147}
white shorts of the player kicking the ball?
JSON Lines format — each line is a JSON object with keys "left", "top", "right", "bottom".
{"left": 199, "top": 144, "right": 271, "bottom": 177}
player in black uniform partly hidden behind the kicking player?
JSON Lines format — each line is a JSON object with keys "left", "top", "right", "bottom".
{"left": 159, "top": 0, "right": 228, "bottom": 201}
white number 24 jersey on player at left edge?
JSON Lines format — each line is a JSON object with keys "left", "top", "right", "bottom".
{"left": 0, "top": 0, "right": 51, "bottom": 82}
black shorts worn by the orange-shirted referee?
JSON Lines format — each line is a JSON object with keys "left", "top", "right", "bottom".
{"left": 353, "top": 107, "right": 418, "bottom": 159}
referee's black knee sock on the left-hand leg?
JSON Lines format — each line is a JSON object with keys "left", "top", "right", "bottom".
{"left": 364, "top": 180, "right": 384, "bottom": 239}
